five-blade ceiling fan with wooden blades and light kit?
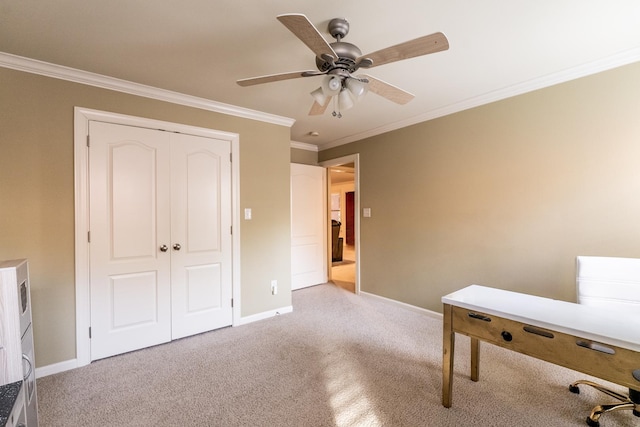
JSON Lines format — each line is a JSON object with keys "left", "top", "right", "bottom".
{"left": 237, "top": 13, "right": 449, "bottom": 117}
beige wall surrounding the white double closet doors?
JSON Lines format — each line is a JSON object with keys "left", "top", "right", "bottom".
{"left": 0, "top": 68, "right": 291, "bottom": 366}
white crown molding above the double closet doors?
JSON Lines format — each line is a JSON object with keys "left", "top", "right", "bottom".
{"left": 0, "top": 52, "right": 295, "bottom": 127}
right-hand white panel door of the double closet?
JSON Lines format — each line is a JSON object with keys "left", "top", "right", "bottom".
{"left": 171, "top": 134, "right": 232, "bottom": 339}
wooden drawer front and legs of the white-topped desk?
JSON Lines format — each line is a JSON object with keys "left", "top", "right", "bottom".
{"left": 442, "top": 288, "right": 640, "bottom": 408}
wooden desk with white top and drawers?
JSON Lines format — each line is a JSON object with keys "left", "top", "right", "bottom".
{"left": 442, "top": 285, "right": 640, "bottom": 408}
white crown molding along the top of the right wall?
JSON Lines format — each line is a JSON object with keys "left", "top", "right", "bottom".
{"left": 320, "top": 48, "right": 640, "bottom": 151}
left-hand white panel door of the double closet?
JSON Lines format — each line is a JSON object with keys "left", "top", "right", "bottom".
{"left": 89, "top": 122, "right": 171, "bottom": 360}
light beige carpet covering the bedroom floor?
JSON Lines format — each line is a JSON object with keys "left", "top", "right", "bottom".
{"left": 38, "top": 284, "right": 640, "bottom": 427}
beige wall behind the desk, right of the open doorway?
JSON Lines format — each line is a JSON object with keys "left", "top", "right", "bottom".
{"left": 319, "top": 64, "right": 640, "bottom": 311}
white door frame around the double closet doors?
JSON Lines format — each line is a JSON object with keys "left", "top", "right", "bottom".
{"left": 73, "top": 107, "right": 241, "bottom": 367}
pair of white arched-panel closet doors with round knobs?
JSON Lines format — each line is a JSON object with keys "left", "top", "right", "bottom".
{"left": 89, "top": 121, "right": 233, "bottom": 360}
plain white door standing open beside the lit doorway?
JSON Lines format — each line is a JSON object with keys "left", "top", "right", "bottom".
{"left": 291, "top": 163, "right": 327, "bottom": 289}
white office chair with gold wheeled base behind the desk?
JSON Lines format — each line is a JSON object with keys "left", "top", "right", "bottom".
{"left": 569, "top": 256, "right": 640, "bottom": 427}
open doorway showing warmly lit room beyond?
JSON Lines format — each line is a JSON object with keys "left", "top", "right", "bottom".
{"left": 322, "top": 155, "right": 360, "bottom": 294}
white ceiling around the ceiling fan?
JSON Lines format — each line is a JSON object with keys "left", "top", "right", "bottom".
{"left": 0, "top": 0, "right": 640, "bottom": 148}
